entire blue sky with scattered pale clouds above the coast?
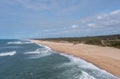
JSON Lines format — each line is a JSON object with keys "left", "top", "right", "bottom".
{"left": 0, "top": 0, "right": 120, "bottom": 39}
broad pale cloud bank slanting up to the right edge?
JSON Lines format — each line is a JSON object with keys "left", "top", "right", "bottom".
{"left": 41, "top": 10, "right": 120, "bottom": 34}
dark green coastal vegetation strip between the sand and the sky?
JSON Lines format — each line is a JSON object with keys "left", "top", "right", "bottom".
{"left": 34, "top": 34, "right": 120, "bottom": 48}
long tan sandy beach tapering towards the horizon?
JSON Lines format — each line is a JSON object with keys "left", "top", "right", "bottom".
{"left": 32, "top": 40, "right": 120, "bottom": 77}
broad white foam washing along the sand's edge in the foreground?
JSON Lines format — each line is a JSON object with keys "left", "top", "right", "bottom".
{"left": 59, "top": 53, "right": 118, "bottom": 79}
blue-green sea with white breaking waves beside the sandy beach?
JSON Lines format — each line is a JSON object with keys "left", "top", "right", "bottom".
{"left": 0, "top": 40, "right": 118, "bottom": 79}
